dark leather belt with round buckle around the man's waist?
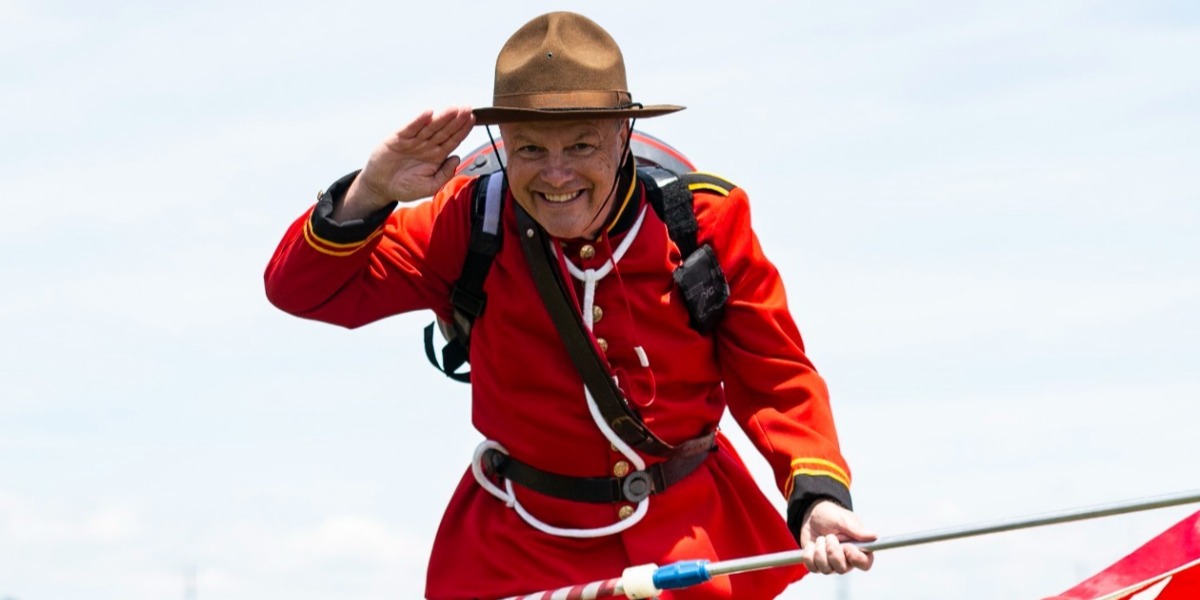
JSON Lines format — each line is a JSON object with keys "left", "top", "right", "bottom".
{"left": 482, "top": 433, "right": 716, "bottom": 504}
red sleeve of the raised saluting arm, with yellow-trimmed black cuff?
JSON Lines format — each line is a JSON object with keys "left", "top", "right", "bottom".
{"left": 264, "top": 175, "right": 474, "bottom": 328}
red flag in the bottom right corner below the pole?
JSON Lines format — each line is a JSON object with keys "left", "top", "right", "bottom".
{"left": 1045, "top": 511, "right": 1200, "bottom": 600}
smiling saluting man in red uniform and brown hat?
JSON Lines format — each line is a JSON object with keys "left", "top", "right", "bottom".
{"left": 265, "top": 13, "right": 874, "bottom": 600}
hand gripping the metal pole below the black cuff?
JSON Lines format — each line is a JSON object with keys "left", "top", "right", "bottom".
{"left": 800, "top": 500, "right": 876, "bottom": 575}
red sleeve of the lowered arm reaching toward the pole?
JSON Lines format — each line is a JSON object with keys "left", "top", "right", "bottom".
{"left": 695, "top": 187, "right": 851, "bottom": 532}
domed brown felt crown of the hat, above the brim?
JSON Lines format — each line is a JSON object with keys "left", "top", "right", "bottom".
{"left": 493, "top": 12, "right": 630, "bottom": 108}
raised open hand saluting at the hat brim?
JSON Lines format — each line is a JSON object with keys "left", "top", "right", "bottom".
{"left": 332, "top": 107, "right": 475, "bottom": 222}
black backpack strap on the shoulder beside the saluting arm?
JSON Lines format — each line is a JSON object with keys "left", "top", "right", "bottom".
{"left": 425, "top": 174, "right": 504, "bottom": 382}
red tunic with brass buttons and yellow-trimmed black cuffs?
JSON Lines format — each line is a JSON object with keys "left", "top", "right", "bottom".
{"left": 266, "top": 171, "right": 850, "bottom": 600}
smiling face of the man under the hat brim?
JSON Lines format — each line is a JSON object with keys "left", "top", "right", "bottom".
{"left": 500, "top": 119, "right": 628, "bottom": 239}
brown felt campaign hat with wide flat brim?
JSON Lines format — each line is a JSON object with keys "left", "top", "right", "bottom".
{"left": 473, "top": 12, "right": 684, "bottom": 125}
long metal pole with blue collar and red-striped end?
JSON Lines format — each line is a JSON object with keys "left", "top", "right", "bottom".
{"left": 504, "top": 490, "right": 1200, "bottom": 600}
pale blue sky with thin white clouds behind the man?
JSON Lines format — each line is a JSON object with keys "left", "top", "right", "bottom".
{"left": 0, "top": 0, "right": 1200, "bottom": 600}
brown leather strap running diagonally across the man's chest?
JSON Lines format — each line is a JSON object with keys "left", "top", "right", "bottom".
{"left": 512, "top": 204, "right": 714, "bottom": 457}
